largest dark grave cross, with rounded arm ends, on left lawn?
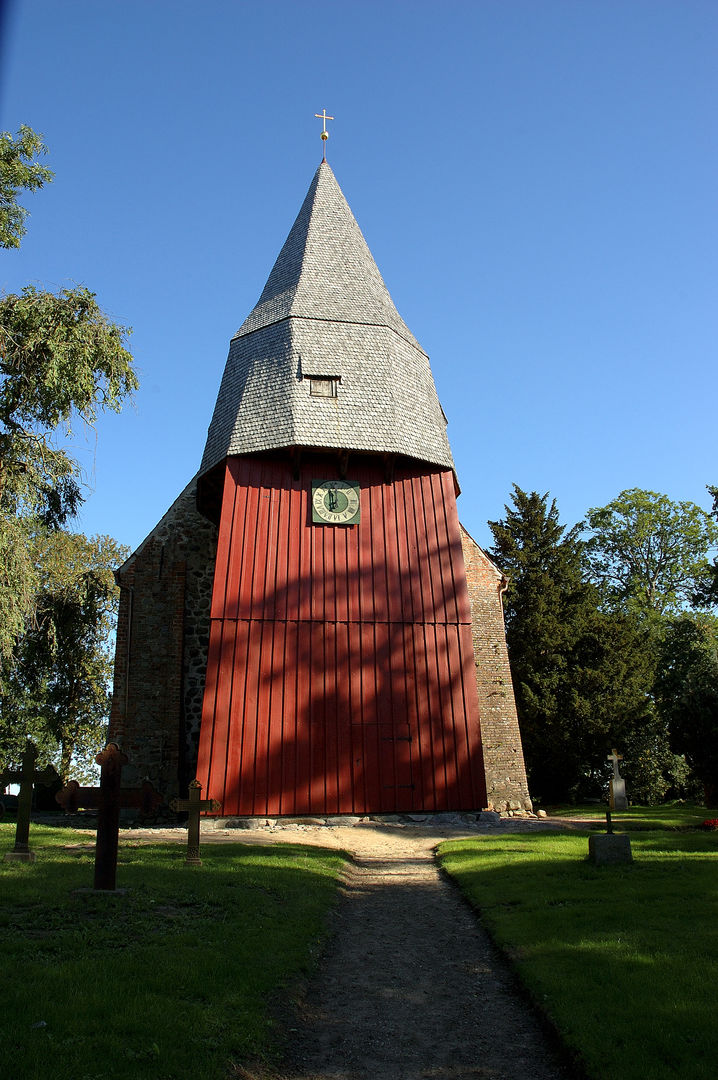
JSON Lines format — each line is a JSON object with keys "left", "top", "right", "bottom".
{"left": 55, "top": 743, "right": 162, "bottom": 892}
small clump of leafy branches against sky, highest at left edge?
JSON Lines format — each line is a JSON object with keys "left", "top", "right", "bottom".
{"left": 0, "top": 125, "right": 53, "bottom": 247}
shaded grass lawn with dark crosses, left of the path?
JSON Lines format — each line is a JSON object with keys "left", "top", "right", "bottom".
{"left": 0, "top": 823, "right": 344, "bottom": 1080}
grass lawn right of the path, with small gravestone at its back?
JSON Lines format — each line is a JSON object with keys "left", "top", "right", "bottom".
{"left": 441, "top": 808, "right": 718, "bottom": 1080}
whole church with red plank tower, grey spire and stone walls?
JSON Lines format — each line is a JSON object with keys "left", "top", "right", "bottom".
{"left": 111, "top": 150, "right": 530, "bottom": 816}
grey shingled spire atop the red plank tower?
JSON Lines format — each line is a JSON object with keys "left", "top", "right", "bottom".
{"left": 200, "top": 162, "right": 453, "bottom": 474}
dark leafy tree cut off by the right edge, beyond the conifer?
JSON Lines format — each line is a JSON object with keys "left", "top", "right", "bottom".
{"left": 654, "top": 615, "right": 718, "bottom": 807}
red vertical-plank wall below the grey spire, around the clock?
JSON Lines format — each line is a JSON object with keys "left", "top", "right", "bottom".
{"left": 198, "top": 458, "right": 486, "bottom": 816}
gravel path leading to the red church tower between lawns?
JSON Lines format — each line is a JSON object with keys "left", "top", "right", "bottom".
{"left": 123, "top": 820, "right": 575, "bottom": 1080}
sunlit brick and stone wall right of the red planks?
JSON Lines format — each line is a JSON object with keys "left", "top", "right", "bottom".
{"left": 461, "top": 526, "right": 532, "bottom": 811}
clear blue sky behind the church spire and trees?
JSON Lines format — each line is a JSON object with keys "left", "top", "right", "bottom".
{"left": 0, "top": 0, "right": 718, "bottom": 546}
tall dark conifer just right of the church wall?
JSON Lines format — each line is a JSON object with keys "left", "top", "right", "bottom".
{"left": 489, "top": 486, "right": 652, "bottom": 801}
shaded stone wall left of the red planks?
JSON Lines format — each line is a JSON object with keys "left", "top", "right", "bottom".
{"left": 109, "top": 481, "right": 217, "bottom": 798}
